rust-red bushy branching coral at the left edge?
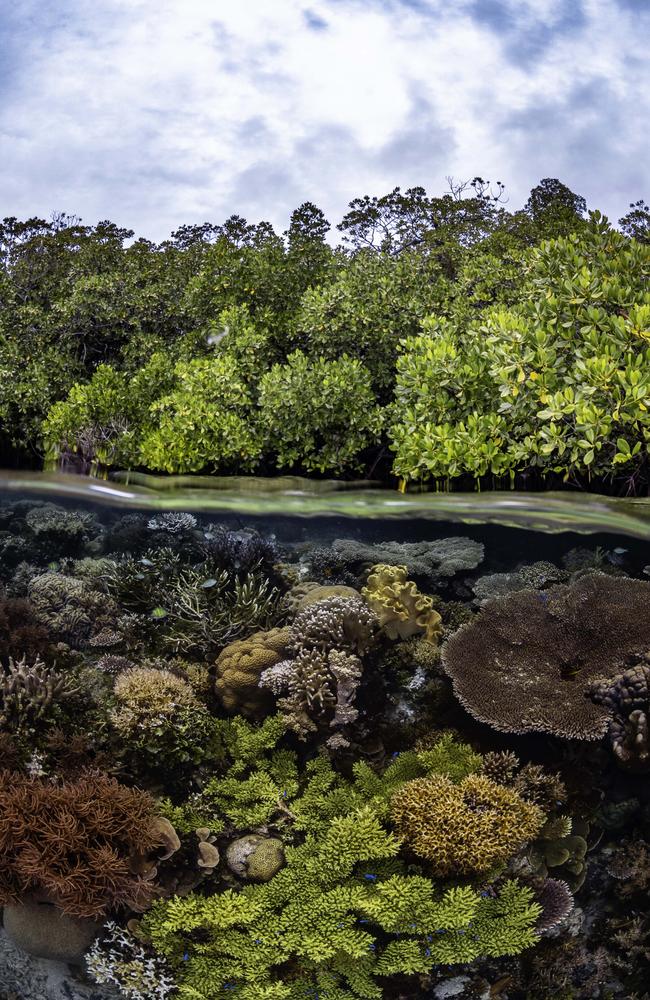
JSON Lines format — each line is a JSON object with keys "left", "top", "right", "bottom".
{"left": 0, "top": 771, "right": 163, "bottom": 917}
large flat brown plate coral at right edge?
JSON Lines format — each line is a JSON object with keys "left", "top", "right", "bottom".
{"left": 442, "top": 574, "right": 650, "bottom": 740}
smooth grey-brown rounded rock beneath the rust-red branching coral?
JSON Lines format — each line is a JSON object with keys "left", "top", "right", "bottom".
{"left": 3, "top": 902, "right": 102, "bottom": 963}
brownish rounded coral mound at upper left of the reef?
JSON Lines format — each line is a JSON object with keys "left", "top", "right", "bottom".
{"left": 29, "top": 573, "right": 118, "bottom": 649}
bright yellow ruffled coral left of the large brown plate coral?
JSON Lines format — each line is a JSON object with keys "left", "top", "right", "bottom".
{"left": 361, "top": 563, "right": 442, "bottom": 644}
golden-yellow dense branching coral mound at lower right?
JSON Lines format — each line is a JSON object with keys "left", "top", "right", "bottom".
{"left": 391, "top": 774, "right": 544, "bottom": 875}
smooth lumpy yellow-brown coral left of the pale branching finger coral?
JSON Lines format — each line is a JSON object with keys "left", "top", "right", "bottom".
{"left": 215, "top": 628, "right": 291, "bottom": 717}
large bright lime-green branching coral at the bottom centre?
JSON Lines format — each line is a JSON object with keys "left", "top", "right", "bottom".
{"left": 142, "top": 807, "right": 541, "bottom": 1000}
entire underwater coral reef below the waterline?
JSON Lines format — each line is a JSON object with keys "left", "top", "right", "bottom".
{"left": 0, "top": 473, "right": 650, "bottom": 1000}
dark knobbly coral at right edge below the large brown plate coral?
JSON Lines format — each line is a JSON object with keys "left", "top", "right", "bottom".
{"left": 589, "top": 653, "right": 650, "bottom": 771}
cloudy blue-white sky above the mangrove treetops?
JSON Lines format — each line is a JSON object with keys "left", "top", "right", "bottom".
{"left": 0, "top": 0, "right": 650, "bottom": 241}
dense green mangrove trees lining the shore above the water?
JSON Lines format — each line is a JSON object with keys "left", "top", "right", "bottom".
{"left": 0, "top": 178, "right": 650, "bottom": 494}
